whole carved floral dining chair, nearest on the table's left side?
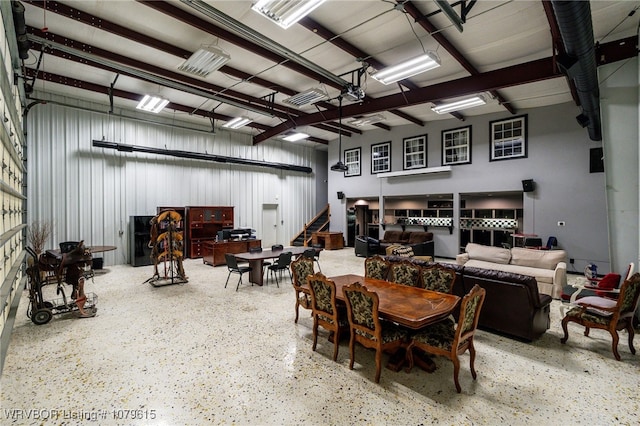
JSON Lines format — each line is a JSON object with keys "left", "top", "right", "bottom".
{"left": 342, "top": 283, "right": 408, "bottom": 383}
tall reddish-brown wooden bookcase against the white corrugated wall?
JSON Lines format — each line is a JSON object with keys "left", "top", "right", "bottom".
{"left": 185, "top": 206, "right": 233, "bottom": 259}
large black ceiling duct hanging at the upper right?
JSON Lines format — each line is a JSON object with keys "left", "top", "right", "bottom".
{"left": 551, "top": 0, "right": 602, "bottom": 141}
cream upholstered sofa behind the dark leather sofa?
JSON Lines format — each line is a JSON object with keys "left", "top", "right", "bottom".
{"left": 456, "top": 243, "right": 567, "bottom": 299}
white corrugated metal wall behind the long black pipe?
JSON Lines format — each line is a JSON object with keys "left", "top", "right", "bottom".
{"left": 26, "top": 93, "right": 326, "bottom": 265}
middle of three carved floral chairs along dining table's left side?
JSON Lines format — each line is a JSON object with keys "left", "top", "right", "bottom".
{"left": 307, "top": 272, "right": 347, "bottom": 361}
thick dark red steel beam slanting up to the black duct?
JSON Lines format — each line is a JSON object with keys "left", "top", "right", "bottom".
{"left": 253, "top": 58, "right": 562, "bottom": 144}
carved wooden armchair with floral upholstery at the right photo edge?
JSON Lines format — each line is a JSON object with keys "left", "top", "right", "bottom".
{"left": 560, "top": 272, "right": 640, "bottom": 361}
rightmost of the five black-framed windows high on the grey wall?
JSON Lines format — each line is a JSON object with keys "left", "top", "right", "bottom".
{"left": 489, "top": 115, "right": 527, "bottom": 161}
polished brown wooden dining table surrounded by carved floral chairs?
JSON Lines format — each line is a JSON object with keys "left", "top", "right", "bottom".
{"left": 329, "top": 274, "right": 460, "bottom": 371}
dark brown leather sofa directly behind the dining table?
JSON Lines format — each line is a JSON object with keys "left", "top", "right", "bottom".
{"left": 387, "top": 256, "right": 552, "bottom": 341}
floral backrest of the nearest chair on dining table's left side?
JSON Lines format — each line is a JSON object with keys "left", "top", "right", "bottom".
{"left": 342, "top": 283, "right": 382, "bottom": 342}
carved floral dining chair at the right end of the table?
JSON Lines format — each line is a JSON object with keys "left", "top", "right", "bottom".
{"left": 406, "top": 284, "right": 486, "bottom": 393}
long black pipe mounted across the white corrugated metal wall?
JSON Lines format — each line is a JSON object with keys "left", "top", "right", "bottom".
{"left": 92, "top": 139, "right": 313, "bottom": 173}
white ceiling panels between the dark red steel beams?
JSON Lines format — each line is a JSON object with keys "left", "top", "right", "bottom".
{"left": 16, "top": 0, "right": 640, "bottom": 149}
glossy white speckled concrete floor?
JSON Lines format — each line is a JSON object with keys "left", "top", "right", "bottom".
{"left": 0, "top": 249, "right": 640, "bottom": 425}
